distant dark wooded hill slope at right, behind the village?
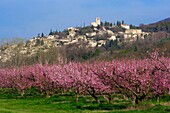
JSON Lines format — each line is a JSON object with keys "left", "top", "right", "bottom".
{"left": 139, "top": 18, "right": 170, "bottom": 33}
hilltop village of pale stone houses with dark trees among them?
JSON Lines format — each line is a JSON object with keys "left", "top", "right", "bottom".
{"left": 0, "top": 17, "right": 149, "bottom": 62}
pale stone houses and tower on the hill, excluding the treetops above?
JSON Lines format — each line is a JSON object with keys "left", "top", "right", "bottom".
{"left": 0, "top": 17, "right": 149, "bottom": 62}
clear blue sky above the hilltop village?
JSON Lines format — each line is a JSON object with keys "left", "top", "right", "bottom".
{"left": 0, "top": 0, "right": 170, "bottom": 41}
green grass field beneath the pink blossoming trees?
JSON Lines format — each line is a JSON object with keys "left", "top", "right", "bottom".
{"left": 0, "top": 90, "right": 170, "bottom": 113}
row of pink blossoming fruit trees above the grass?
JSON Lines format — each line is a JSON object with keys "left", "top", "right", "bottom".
{"left": 0, "top": 55, "right": 170, "bottom": 104}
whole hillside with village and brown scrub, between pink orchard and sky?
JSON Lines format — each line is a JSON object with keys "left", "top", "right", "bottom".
{"left": 0, "top": 18, "right": 170, "bottom": 68}
